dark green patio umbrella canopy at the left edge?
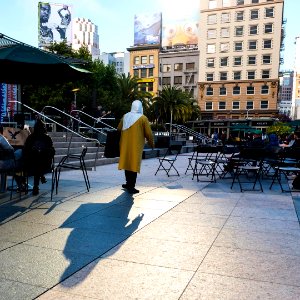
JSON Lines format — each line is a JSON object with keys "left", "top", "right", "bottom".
{"left": 0, "top": 33, "right": 91, "bottom": 84}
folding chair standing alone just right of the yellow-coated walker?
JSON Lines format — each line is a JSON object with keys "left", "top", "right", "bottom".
{"left": 155, "top": 144, "right": 182, "bottom": 177}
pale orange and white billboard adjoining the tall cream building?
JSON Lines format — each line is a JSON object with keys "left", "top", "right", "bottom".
{"left": 162, "top": 19, "right": 199, "bottom": 47}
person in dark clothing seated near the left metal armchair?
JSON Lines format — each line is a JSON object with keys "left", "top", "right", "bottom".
{"left": 23, "top": 119, "right": 55, "bottom": 195}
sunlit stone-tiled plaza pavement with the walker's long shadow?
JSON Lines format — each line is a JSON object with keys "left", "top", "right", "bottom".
{"left": 0, "top": 154, "right": 300, "bottom": 300}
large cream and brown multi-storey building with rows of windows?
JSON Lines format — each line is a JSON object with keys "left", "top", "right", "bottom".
{"left": 198, "top": 0, "right": 284, "bottom": 119}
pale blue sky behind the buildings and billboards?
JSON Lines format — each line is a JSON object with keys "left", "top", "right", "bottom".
{"left": 0, "top": 0, "right": 300, "bottom": 70}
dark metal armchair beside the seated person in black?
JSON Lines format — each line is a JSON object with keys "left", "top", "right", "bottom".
{"left": 52, "top": 146, "right": 91, "bottom": 194}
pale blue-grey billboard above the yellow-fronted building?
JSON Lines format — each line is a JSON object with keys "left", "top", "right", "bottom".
{"left": 134, "top": 13, "right": 162, "bottom": 46}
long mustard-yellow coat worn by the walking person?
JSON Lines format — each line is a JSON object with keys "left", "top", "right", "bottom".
{"left": 118, "top": 115, "right": 154, "bottom": 173}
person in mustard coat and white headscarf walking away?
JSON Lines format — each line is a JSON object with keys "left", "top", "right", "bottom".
{"left": 118, "top": 100, "right": 154, "bottom": 194}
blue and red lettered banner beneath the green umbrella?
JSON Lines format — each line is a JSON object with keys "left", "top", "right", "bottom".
{"left": 0, "top": 83, "right": 18, "bottom": 123}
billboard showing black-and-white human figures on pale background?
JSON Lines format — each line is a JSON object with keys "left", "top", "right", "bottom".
{"left": 38, "top": 2, "right": 72, "bottom": 47}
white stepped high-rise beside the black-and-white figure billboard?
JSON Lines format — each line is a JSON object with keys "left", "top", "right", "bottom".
{"left": 72, "top": 18, "right": 100, "bottom": 60}
